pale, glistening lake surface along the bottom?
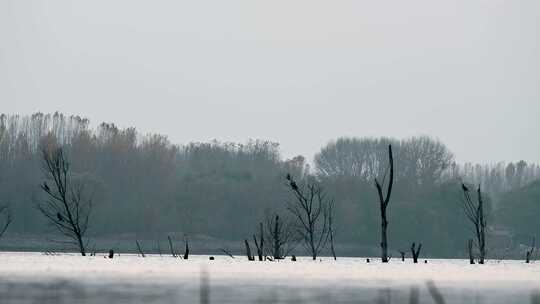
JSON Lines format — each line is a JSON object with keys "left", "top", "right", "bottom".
{"left": 0, "top": 253, "right": 540, "bottom": 303}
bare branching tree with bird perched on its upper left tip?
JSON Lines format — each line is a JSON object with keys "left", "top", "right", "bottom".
{"left": 287, "top": 174, "right": 331, "bottom": 260}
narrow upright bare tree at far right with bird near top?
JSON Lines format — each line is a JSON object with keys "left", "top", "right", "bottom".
{"left": 461, "top": 184, "right": 487, "bottom": 264}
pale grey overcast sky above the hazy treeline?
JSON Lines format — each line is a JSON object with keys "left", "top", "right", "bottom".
{"left": 0, "top": 0, "right": 540, "bottom": 162}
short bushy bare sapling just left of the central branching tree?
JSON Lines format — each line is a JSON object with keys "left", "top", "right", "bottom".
{"left": 264, "top": 214, "right": 296, "bottom": 260}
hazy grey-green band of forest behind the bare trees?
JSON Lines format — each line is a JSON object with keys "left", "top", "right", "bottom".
{"left": 0, "top": 112, "right": 540, "bottom": 256}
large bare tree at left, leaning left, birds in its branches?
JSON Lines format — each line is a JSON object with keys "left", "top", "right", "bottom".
{"left": 37, "top": 146, "right": 92, "bottom": 256}
